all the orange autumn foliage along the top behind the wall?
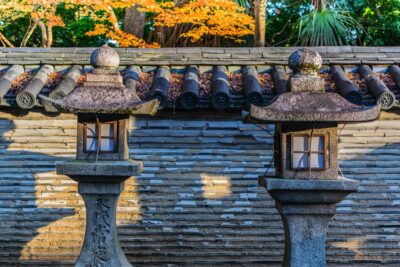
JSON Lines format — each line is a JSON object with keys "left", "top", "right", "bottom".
{"left": 0, "top": 0, "right": 255, "bottom": 47}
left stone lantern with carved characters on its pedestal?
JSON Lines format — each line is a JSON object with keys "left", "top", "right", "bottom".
{"left": 41, "top": 45, "right": 159, "bottom": 267}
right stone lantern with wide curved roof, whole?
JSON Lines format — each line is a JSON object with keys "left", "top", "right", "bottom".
{"left": 246, "top": 49, "right": 380, "bottom": 267}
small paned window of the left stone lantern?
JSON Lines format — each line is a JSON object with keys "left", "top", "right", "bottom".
{"left": 84, "top": 122, "right": 117, "bottom": 153}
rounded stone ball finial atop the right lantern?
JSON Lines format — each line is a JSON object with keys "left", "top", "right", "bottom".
{"left": 289, "top": 48, "right": 322, "bottom": 75}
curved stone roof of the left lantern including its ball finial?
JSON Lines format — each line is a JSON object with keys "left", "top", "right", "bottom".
{"left": 40, "top": 45, "right": 159, "bottom": 115}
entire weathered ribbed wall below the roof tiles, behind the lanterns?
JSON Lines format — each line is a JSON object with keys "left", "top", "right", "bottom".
{"left": 0, "top": 112, "right": 400, "bottom": 266}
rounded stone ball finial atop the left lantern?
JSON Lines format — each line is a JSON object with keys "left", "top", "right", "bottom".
{"left": 90, "top": 44, "right": 119, "bottom": 70}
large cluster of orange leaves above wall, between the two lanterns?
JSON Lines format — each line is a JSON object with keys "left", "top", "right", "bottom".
{"left": 84, "top": 0, "right": 255, "bottom": 47}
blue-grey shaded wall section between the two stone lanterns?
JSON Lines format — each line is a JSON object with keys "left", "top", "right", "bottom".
{"left": 120, "top": 118, "right": 284, "bottom": 266}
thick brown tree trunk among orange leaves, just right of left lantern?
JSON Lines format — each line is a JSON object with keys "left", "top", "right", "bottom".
{"left": 124, "top": 6, "right": 146, "bottom": 38}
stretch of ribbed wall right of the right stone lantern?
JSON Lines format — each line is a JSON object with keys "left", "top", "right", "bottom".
{"left": 327, "top": 139, "right": 400, "bottom": 266}
